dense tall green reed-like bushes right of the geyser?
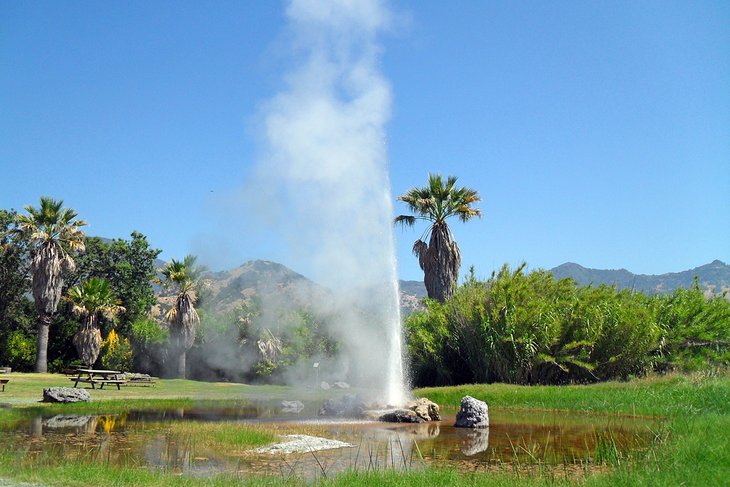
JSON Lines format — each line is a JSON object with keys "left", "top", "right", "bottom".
{"left": 405, "top": 264, "right": 730, "bottom": 386}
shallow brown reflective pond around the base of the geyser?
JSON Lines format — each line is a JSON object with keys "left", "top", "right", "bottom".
{"left": 0, "top": 402, "right": 658, "bottom": 479}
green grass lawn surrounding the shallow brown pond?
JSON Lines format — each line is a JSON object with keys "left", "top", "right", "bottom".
{"left": 0, "top": 372, "right": 730, "bottom": 486}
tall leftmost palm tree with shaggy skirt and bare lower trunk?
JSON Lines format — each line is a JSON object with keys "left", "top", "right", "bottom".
{"left": 15, "top": 196, "right": 86, "bottom": 372}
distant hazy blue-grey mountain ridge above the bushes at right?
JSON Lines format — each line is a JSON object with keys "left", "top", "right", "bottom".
{"left": 550, "top": 260, "right": 730, "bottom": 295}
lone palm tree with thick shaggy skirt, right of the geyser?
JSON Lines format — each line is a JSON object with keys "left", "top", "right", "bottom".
{"left": 395, "top": 174, "right": 481, "bottom": 303}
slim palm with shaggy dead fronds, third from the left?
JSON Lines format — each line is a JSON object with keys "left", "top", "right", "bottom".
{"left": 157, "top": 255, "right": 202, "bottom": 379}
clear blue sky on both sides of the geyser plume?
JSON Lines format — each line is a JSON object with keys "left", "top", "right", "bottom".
{"left": 0, "top": 0, "right": 730, "bottom": 279}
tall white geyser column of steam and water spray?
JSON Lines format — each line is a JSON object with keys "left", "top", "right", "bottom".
{"left": 254, "top": 0, "right": 407, "bottom": 404}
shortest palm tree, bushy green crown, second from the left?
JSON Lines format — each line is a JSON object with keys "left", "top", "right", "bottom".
{"left": 65, "top": 277, "right": 125, "bottom": 366}
